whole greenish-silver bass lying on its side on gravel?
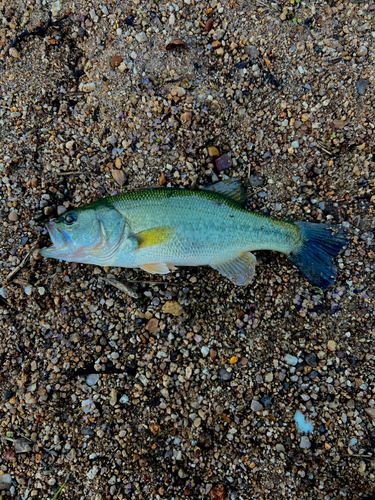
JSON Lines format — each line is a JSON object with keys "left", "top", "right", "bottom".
{"left": 40, "top": 178, "right": 349, "bottom": 289}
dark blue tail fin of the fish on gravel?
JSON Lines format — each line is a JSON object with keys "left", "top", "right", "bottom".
{"left": 289, "top": 222, "right": 350, "bottom": 289}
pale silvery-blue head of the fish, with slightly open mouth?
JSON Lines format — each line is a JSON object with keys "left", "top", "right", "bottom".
{"left": 40, "top": 203, "right": 128, "bottom": 266}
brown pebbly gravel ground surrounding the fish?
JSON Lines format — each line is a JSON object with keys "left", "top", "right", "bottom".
{"left": 0, "top": 0, "right": 375, "bottom": 500}
